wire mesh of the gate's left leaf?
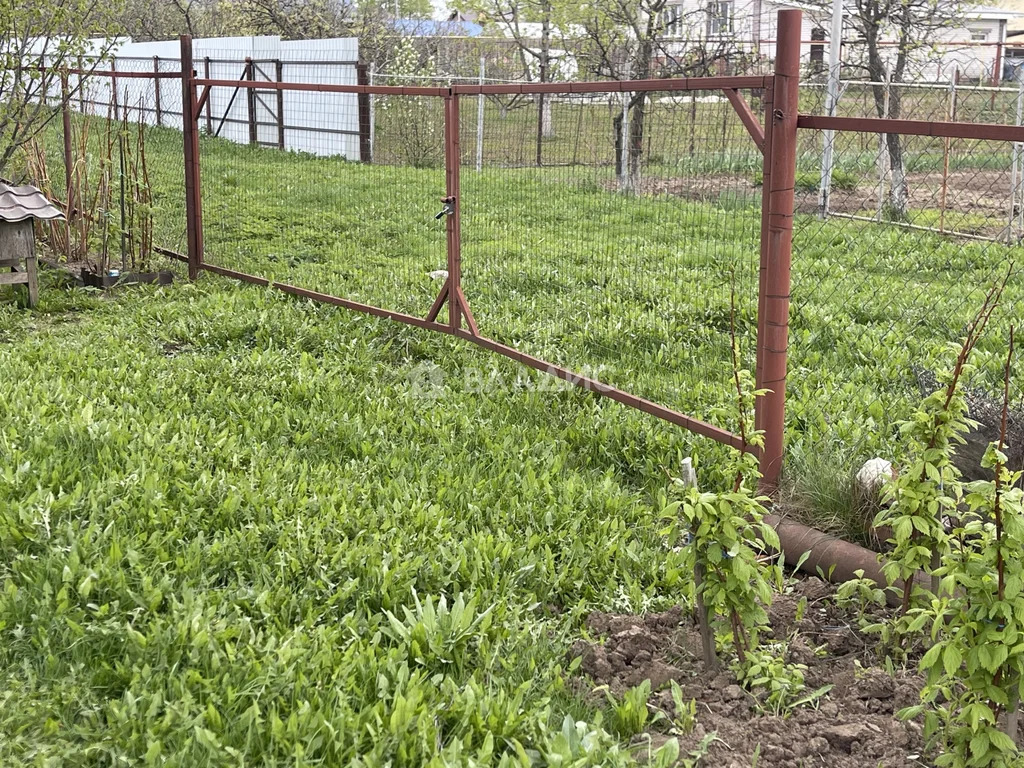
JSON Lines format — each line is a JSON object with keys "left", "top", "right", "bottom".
{"left": 200, "top": 80, "right": 446, "bottom": 316}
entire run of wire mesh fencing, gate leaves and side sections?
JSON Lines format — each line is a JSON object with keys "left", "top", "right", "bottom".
{"left": 19, "top": 22, "right": 1024, "bottom": 499}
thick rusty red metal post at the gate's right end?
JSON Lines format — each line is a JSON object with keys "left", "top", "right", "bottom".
{"left": 756, "top": 10, "right": 801, "bottom": 494}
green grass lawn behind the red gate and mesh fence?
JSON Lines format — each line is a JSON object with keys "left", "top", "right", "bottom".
{"left": 32, "top": 115, "right": 1022, "bottom": 518}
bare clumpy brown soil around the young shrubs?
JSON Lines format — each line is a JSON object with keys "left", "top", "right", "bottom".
{"left": 571, "top": 578, "right": 925, "bottom": 768}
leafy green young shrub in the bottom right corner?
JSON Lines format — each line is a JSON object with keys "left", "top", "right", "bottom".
{"left": 902, "top": 331, "right": 1024, "bottom": 766}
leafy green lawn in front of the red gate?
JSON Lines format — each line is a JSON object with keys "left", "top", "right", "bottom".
{"left": 0, "top": 275, "right": 700, "bottom": 766}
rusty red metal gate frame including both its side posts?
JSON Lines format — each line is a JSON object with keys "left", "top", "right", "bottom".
{"left": 169, "top": 15, "right": 801, "bottom": 492}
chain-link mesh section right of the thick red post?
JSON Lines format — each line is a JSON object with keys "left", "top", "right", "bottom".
{"left": 786, "top": 126, "right": 1024, "bottom": 524}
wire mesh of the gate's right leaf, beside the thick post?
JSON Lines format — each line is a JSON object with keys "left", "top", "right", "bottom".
{"left": 461, "top": 91, "right": 763, "bottom": 429}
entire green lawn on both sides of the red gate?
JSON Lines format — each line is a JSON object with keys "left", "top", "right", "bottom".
{"left": 0, "top": 88, "right": 1022, "bottom": 767}
